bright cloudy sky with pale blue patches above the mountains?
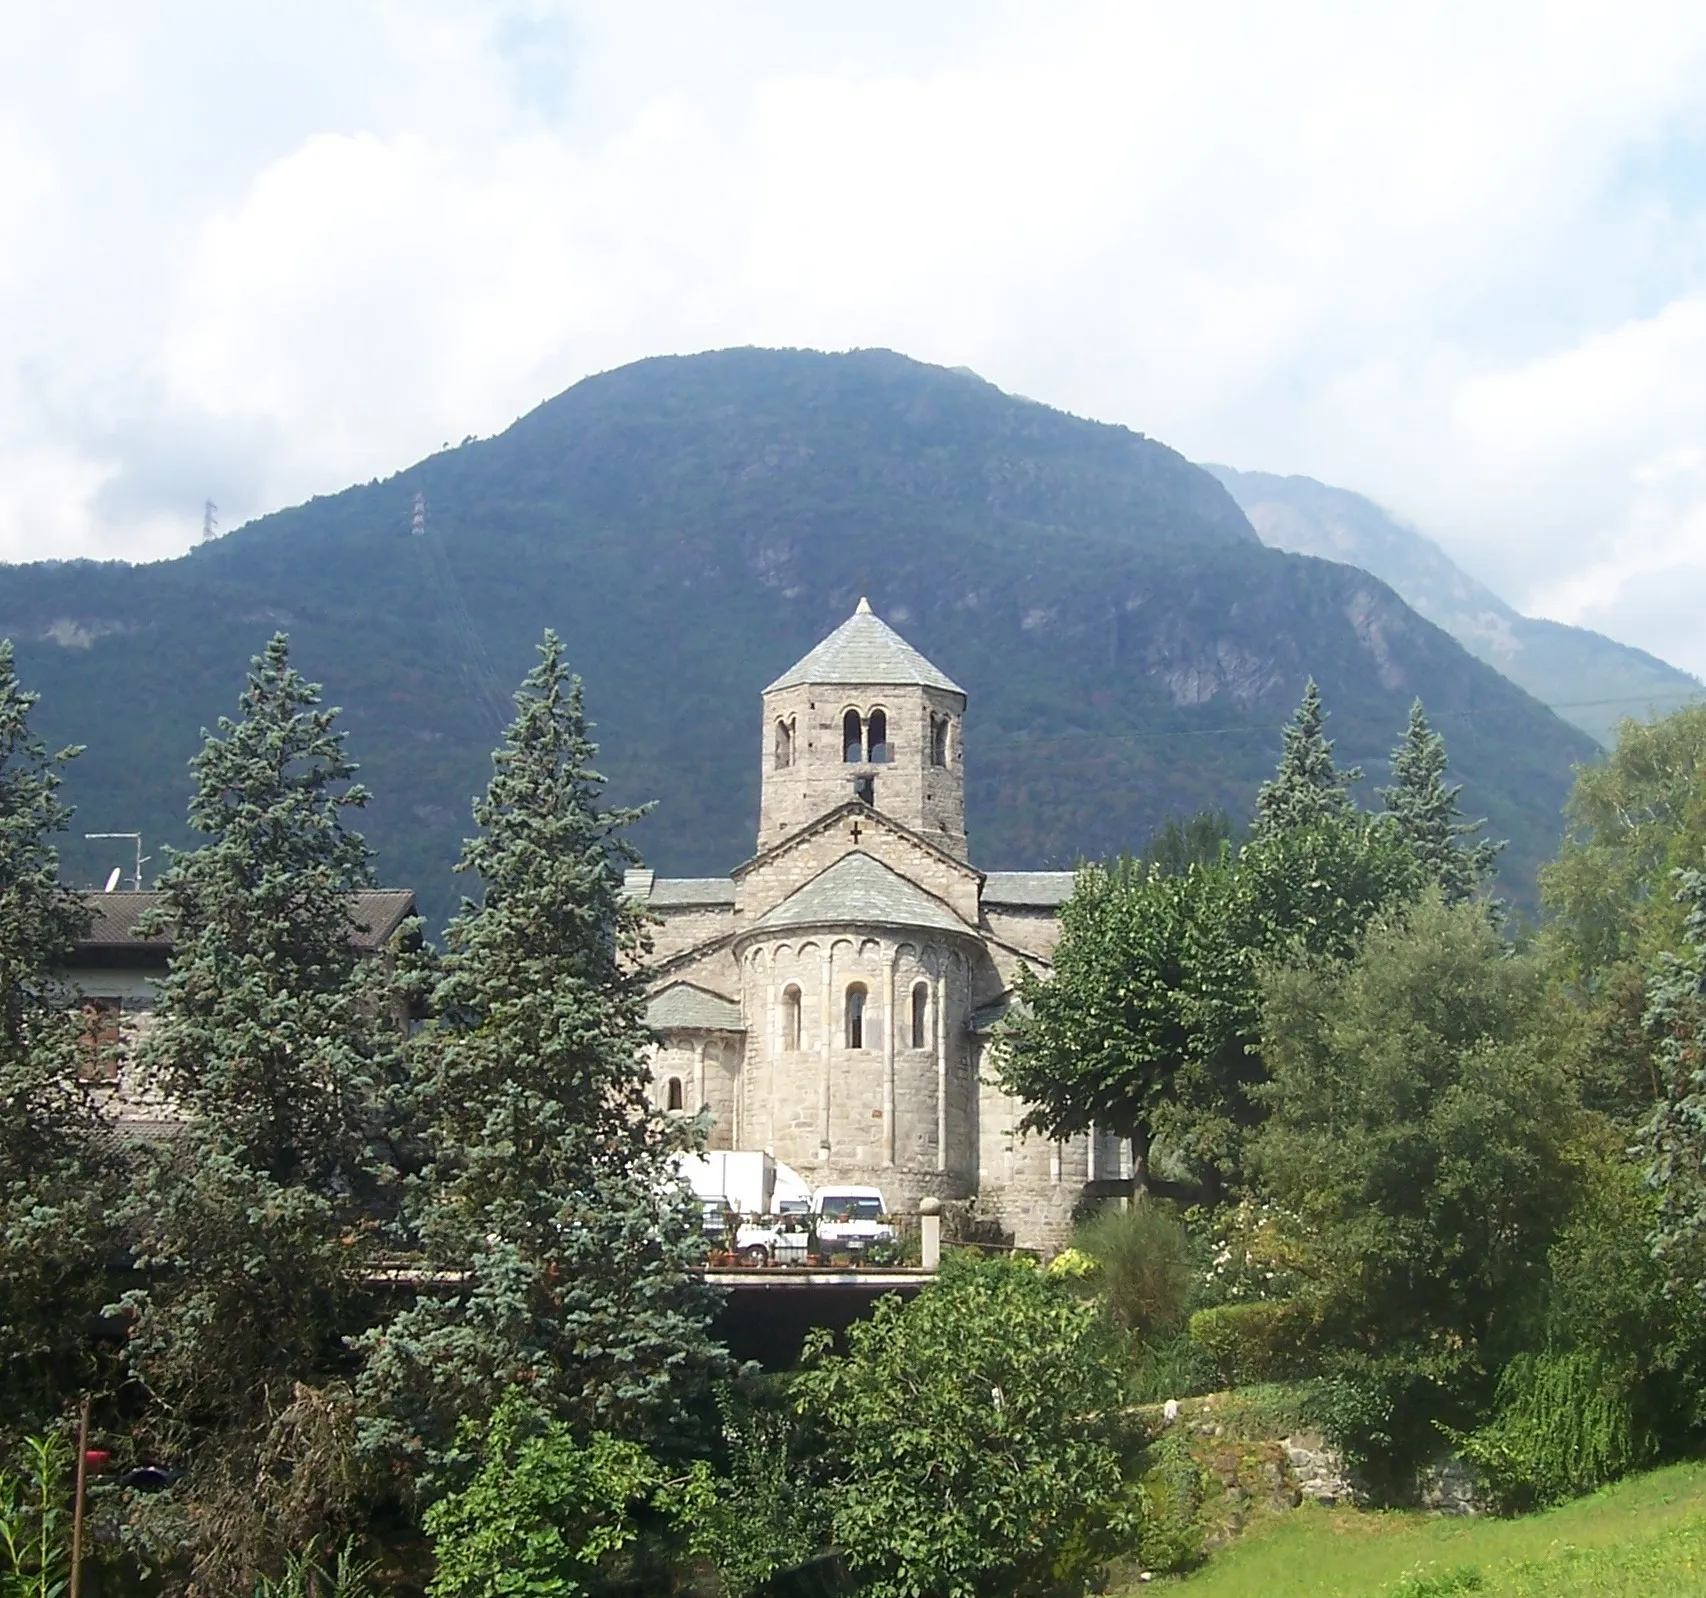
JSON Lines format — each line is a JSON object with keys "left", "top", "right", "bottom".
{"left": 0, "top": 0, "right": 1706, "bottom": 674}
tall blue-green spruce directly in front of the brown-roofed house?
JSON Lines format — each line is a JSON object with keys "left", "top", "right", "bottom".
{"left": 126, "top": 634, "right": 391, "bottom": 1591}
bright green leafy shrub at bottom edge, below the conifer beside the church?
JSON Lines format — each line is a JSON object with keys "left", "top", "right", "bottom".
{"left": 425, "top": 1388, "right": 665, "bottom": 1598}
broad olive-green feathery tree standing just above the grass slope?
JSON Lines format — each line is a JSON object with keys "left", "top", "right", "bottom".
{"left": 1257, "top": 890, "right": 1576, "bottom": 1467}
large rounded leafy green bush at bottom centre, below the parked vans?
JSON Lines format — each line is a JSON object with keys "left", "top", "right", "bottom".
{"left": 795, "top": 1255, "right": 1133, "bottom": 1598}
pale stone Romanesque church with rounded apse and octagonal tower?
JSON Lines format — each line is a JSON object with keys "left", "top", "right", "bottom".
{"left": 628, "top": 600, "right": 1123, "bottom": 1247}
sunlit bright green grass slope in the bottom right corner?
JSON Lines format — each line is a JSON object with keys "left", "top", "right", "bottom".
{"left": 1153, "top": 1463, "right": 1706, "bottom": 1598}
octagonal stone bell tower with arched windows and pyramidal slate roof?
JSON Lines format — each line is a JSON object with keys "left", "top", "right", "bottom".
{"left": 757, "top": 599, "right": 966, "bottom": 860}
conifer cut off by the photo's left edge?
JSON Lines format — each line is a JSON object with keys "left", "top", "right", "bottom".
{"left": 0, "top": 640, "right": 116, "bottom": 1431}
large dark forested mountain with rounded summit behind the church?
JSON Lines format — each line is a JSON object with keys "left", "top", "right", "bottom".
{"left": 0, "top": 350, "right": 1593, "bottom": 916}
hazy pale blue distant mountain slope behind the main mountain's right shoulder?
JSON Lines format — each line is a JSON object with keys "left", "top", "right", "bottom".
{"left": 1206, "top": 466, "right": 1706, "bottom": 747}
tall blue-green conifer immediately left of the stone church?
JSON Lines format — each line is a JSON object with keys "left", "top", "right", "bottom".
{"left": 363, "top": 633, "right": 717, "bottom": 1465}
